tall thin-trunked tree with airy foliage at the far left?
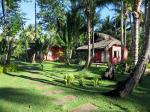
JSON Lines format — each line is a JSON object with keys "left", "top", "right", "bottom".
{"left": 1, "top": 0, "right": 20, "bottom": 64}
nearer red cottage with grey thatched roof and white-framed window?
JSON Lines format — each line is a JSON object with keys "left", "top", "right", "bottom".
{"left": 77, "top": 33, "right": 128, "bottom": 64}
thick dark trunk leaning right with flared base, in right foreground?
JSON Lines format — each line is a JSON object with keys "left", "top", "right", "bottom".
{"left": 104, "top": 2, "right": 150, "bottom": 97}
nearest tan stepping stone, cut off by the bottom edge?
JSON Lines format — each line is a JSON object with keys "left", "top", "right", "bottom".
{"left": 70, "top": 103, "right": 97, "bottom": 112}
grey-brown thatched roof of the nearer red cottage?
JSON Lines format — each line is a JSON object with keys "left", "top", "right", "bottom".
{"left": 77, "top": 33, "right": 121, "bottom": 50}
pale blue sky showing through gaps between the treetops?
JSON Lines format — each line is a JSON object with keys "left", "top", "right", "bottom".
{"left": 21, "top": 0, "right": 114, "bottom": 26}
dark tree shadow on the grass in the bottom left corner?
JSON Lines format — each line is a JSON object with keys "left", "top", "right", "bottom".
{"left": 0, "top": 88, "right": 54, "bottom": 106}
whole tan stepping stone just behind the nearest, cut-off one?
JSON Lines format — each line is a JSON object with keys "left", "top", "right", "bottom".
{"left": 54, "top": 95, "right": 76, "bottom": 106}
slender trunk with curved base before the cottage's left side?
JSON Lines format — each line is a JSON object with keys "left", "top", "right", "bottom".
{"left": 84, "top": 15, "right": 91, "bottom": 69}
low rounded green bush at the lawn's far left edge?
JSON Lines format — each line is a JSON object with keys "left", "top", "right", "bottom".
{"left": 4, "top": 64, "right": 18, "bottom": 73}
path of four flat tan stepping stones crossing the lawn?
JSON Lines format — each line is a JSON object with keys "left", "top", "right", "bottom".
{"left": 31, "top": 78, "right": 97, "bottom": 112}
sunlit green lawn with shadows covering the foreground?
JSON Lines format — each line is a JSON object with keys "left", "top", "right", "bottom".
{"left": 0, "top": 62, "right": 150, "bottom": 112}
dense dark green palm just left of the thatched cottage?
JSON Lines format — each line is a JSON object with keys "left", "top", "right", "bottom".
{"left": 57, "top": 3, "right": 84, "bottom": 65}
